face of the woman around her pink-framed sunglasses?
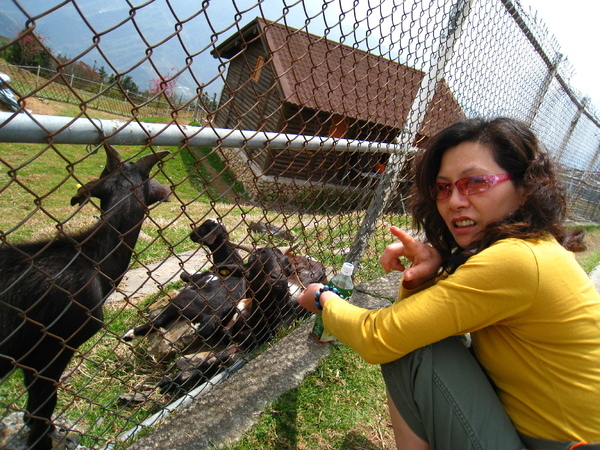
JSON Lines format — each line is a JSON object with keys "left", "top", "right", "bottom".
{"left": 436, "top": 142, "right": 521, "bottom": 249}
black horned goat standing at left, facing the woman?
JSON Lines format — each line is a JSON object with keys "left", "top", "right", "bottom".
{"left": 0, "top": 145, "right": 170, "bottom": 450}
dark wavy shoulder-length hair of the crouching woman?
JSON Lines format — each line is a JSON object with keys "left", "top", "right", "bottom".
{"left": 411, "top": 117, "right": 585, "bottom": 273}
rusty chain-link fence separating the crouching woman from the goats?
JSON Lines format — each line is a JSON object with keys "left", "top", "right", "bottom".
{"left": 0, "top": 0, "right": 600, "bottom": 448}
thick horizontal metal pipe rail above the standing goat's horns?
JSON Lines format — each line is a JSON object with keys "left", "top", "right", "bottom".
{"left": 0, "top": 112, "right": 402, "bottom": 153}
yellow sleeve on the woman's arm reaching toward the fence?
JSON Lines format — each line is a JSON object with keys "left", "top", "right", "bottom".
{"left": 323, "top": 239, "right": 539, "bottom": 364}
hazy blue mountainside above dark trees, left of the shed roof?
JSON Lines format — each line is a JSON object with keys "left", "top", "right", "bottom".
{"left": 0, "top": 0, "right": 330, "bottom": 97}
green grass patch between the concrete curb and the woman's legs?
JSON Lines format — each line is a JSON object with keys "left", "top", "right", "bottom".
{"left": 214, "top": 345, "right": 391, "bottom": 450}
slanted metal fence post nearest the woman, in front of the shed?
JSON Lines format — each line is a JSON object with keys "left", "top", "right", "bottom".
{"left": 346, "top": 0, "right": 474, "bottom": 266}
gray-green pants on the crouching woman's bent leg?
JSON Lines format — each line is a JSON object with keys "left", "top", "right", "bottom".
{"left": 381, "top": 337, "right": 592, "bottom": 450}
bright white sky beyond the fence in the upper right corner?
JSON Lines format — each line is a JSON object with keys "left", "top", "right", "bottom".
{"left": 521, "top": 0, "right": 600, "bottom": 114}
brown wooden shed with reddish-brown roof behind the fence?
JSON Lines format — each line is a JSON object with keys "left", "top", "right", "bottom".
{"left": 212, "top": 18, "right": 464, "bottom": 192}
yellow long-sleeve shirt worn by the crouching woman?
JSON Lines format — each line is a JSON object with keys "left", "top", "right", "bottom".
{"left": 323, "top": 238, "right": 600, "bottom": 442}
